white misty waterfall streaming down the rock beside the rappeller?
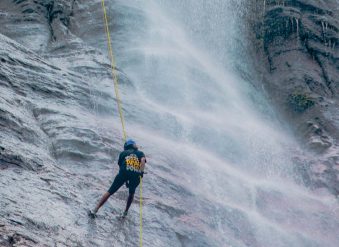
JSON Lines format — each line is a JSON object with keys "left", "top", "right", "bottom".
{"left": 96, "top": 0, "right": 339, "bottom": 247}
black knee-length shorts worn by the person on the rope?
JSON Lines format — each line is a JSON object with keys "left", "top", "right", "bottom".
{"left": 108, "top": 168, "right": 140, "bottom": 195}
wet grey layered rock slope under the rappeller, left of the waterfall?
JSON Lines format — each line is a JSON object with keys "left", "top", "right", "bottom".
{"left": 0, "top": 0, "right": 231, "bottom": 247}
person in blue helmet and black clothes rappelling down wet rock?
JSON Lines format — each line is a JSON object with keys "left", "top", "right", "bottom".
{"left": 89, "top": 139, "right": 146, "bottom": 218}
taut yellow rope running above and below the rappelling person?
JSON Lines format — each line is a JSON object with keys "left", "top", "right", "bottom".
{"left": 101, "top": 0, "right": 142, "bottom": 247}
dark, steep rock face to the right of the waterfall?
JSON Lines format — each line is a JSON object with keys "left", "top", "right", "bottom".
{"left": 250, "top": 0, "right": 339, "bottom": 195}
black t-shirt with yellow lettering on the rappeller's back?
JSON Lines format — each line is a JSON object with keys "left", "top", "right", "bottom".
{"left": 118, "top": 149, "right": 145, "bottom": 173}
